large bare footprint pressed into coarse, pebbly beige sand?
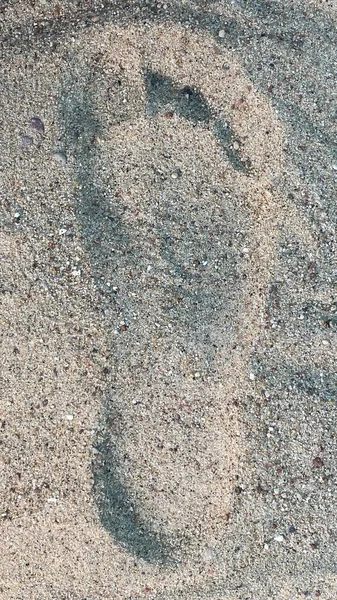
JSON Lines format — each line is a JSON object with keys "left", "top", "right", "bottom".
{"left": 59, "top": 27, "right": 282, "bottom": 562}
